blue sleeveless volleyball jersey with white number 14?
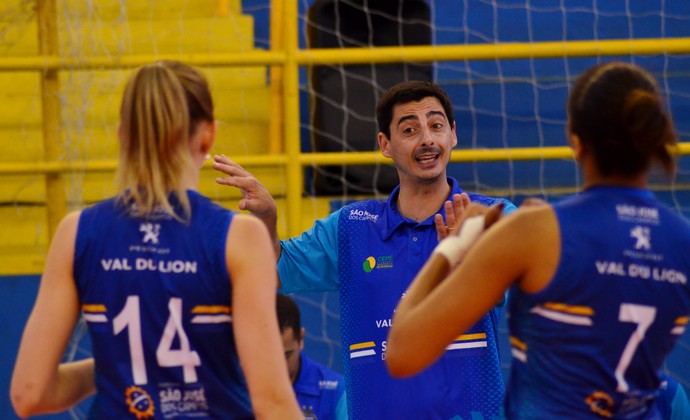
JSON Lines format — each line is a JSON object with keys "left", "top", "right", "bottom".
{"left": 74, "top": 191, "right": 251, "bottom": 418}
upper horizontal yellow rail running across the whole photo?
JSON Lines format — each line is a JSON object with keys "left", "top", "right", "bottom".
{"left": 0, "top": 37, "right": 690, "bottom": 71}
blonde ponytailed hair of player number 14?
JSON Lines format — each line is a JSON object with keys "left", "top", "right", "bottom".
{"left": 118, "top": 61, "right": 213, "bottom": 220}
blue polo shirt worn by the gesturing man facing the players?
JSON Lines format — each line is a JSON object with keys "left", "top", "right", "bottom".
{"left": 278, "top": 178, "right": 515, "bottom": 419}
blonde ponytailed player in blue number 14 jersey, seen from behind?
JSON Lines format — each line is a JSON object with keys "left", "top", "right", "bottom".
{"left": 11, "top": 61, "right": 301, "bottom": 419}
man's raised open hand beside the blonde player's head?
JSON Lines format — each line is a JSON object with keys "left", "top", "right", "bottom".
{"left": 213, "top": 155, "right": 278, "bottom": 224}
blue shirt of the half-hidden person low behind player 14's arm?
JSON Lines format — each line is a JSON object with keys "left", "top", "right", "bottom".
{"left": 292, "top": 353, "right": 347, "bottom": 420}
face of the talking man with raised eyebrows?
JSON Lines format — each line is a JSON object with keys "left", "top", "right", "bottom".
{"left": 378, "top": 96, "right": 458, "bottom": 184}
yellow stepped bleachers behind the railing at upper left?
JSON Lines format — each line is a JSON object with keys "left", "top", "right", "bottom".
{"left": 0, "top": 0, "right": 274, "bottom": 274}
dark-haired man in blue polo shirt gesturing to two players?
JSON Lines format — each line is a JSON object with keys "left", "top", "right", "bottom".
{"left": 214, "top": 81, "right": 515, "bottom": 420}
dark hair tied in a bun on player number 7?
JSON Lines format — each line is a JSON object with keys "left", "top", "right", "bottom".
{"left": 568, "top": 62, "right": 677, "bottom": 176}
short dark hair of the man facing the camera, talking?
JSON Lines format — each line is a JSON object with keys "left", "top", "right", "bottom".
{"left": 376, "top": 80, "right": 455, "bottom": 139}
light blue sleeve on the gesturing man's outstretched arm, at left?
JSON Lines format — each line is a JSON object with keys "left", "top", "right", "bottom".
{"left": 278, "top": 210, "right": 340, "bottom": 293}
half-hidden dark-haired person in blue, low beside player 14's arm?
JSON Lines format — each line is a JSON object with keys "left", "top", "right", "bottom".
{"left": 276, "top": 294, "right": 347, "bottom": 420}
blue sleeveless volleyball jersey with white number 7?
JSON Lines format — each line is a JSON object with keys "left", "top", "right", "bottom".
{"left": 506, "top": 187, "right": 690, "bottom": 418}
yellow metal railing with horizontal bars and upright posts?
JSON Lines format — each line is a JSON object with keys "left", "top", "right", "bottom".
{"left": 0, "top": 0, "right": 690, "bottom": 240}
